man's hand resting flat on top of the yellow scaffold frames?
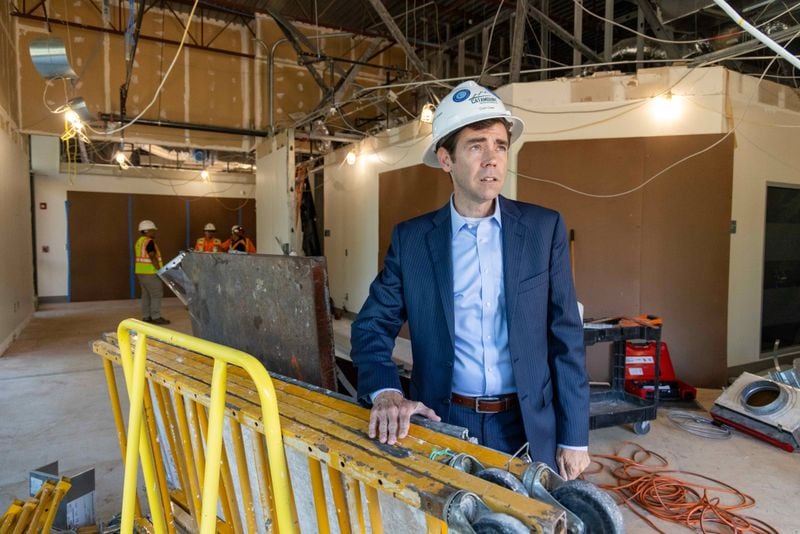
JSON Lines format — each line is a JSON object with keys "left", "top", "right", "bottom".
{"left": 369, "top": 391, "right": 442, "bottom": 445}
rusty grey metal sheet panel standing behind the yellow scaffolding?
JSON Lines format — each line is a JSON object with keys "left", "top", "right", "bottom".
{"left": 159, "top": 251, "right": 336, "bottom": 389}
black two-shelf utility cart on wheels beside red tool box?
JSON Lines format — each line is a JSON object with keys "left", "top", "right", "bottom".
{"left": 583, "top": 316, "right": 661, "bottom": 434}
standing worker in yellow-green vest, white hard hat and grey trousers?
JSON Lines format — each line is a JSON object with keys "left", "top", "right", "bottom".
{"left": 133, "top": 219, "right": 169, "bottom": 324}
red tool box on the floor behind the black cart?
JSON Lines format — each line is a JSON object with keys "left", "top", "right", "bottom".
{"left": 625, "top": 341, "right": 697, "bottom": 401}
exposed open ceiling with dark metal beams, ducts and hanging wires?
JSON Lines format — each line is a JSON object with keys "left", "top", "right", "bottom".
{"left": 12, "top": 0, "right": 800, "bottom": 168}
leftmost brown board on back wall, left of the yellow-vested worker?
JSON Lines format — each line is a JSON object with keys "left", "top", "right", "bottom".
{"left": 67, "top": 191, "right": 130, "bottom": 301}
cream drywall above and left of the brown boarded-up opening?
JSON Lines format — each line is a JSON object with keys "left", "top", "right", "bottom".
{"left": 31, "top": 135, "right": 255, "bottom": 298}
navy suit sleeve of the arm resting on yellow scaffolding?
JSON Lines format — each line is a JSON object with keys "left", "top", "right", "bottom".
{"left": 350, "top": 227, "right": 406, "bottom": 404}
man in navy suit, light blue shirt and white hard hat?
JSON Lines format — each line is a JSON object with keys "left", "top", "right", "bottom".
{"left": 351, "top": 82, "right": 589, "bottom": 479}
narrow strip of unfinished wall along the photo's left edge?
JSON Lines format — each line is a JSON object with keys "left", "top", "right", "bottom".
{"left": 0, "top": 2, "right": 34, "bottom": 355}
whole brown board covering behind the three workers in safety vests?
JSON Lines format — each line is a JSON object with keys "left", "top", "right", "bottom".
{"left": 67, "top": 191, "right": 256, "bottom": 302}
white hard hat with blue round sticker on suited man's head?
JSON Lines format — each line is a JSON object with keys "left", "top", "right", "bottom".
{"left": 422, "top": 81, "right": 525, "bottom": 168}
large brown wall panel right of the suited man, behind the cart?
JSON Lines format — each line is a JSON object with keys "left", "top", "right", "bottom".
{"left": 517, "top": 135, "right": 733, "bottom": 386}
